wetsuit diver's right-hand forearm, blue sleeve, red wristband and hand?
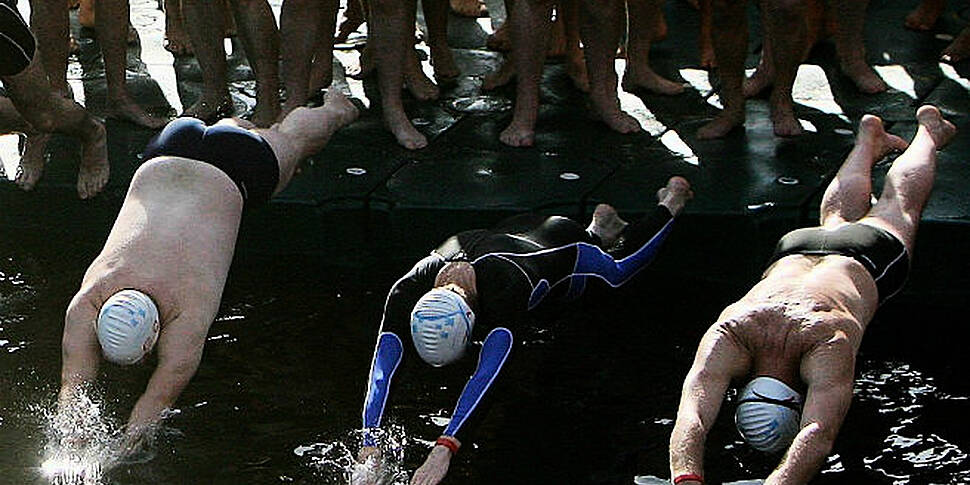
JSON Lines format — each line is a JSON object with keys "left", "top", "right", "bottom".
{"left": 411, "top": 327, "right": 512, "bottom": 485}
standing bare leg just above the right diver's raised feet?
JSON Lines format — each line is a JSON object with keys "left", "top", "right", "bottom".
{"left": 828, "top": 0, "right": 887, "bottom": 94}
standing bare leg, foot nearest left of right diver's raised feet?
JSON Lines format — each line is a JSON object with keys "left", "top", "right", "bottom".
{"left": 762, "top": 0, "right": 808, "bottom": 136}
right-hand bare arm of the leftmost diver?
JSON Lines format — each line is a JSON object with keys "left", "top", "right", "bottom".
{"left": 125, "top": 316, "right": 211, "bottom": 452}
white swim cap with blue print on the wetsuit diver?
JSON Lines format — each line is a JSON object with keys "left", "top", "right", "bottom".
{"left": 411, "top": 288, "right": 475, "bottom": 367}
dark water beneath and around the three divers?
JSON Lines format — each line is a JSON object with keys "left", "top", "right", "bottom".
{"left": 0, "top": 234, "right": 970, "bottom": 484}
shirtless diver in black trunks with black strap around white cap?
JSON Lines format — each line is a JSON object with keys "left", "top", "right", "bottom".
{"left": 670, "top": 106, "right": 956, "bottom": 485}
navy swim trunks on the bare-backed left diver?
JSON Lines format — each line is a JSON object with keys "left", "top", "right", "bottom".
{"left": 142, "top": 118, "right": 280, "bottom": 207}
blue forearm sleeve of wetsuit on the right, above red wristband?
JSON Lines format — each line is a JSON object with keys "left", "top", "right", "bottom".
{"left": 443, "top": 327, "right": 513, "bottom": 442}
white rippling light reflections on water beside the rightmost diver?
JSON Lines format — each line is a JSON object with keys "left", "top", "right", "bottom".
{"left": 855, "top": 362, "right": 970, "bottom": 483}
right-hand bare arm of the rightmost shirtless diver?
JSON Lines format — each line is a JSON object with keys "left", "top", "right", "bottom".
{"left": 765, "top": 340, "right": 855, "bottom": 485}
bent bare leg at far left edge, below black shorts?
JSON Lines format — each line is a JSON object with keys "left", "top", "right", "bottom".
{"left": 2, "top": 57, "right": 109, "bottom": 199}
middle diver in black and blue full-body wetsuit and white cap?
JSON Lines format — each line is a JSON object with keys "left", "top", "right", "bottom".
{"left": 359, "top": 177, "right": 692, "bottom": 484}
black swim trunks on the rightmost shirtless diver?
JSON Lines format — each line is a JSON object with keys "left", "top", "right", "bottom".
{"left": 768, "top": 223, "right": 909, "bottom": 304}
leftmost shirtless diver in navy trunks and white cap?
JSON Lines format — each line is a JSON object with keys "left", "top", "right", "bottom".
{"left": 59, "top": 90, "right": 358, "bottom": 454}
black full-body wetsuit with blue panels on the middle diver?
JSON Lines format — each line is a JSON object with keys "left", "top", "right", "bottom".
{"left": 363, "top": 206, "right": 673, "bottom": 444}
